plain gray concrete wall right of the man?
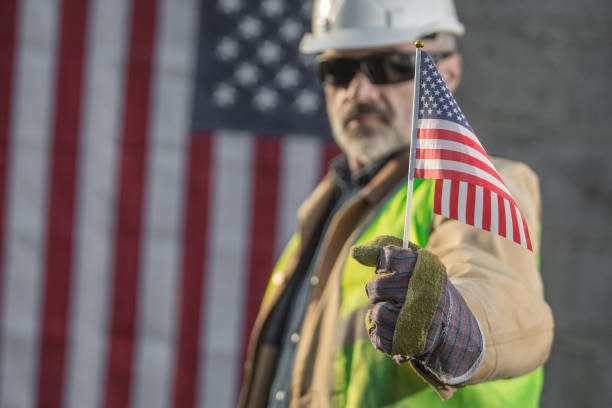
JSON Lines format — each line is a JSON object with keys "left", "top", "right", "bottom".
{"left": 457, "top": 0, "right": 612, "bottom": 407}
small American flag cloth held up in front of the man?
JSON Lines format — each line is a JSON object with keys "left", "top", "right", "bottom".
{"left": 414, "top": 50, "right": 533, "bottom": 251}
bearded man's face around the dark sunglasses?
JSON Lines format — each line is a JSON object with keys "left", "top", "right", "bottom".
{"left": 323, "top": 39, "right": 462, "bottom": 170}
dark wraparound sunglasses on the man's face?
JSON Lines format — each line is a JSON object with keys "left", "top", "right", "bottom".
{"left": 317, "top": 51, "right": 452, "bottom": 88}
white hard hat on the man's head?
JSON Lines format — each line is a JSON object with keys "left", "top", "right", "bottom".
{"left": 300, "top": 0, "right": 465, "bottom": 54}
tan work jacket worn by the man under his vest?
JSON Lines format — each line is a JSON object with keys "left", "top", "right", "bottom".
{"left": 239, "top": 151, "right": 553, "bottom": 407}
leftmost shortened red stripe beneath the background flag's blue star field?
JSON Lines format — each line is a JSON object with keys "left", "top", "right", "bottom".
{"left": 173, "top": 134, "right": 212, "bottom": 407}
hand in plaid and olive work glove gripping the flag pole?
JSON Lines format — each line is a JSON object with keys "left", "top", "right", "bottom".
{"left": 352, "top": 236, "right": 484, "bottom": 385}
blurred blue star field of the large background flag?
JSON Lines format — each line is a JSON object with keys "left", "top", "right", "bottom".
{"left": 193, "top": 0, "right": 330, "bottom": 137}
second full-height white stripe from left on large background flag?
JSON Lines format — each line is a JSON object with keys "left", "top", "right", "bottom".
{"left": 64, "top": 0, "right": 129, "bottom": 408}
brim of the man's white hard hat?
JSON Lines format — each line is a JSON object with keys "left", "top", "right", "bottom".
{"left": 300, "top": 22, "right": 465, "bottom": 54}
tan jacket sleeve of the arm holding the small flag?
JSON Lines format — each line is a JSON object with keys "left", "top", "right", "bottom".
{"left": 427, "top": 159, "right": 553, "bottom": 388}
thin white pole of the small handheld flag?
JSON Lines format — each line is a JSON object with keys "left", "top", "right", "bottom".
{"left": 403, "top": 40, "right": 423, "bottom": 249}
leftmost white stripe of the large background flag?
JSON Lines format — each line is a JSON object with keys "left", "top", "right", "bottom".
{"left": 0, "top": 0, "right": 59, "bottom": 407}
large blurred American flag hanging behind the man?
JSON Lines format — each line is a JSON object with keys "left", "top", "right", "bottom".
{"left": 0, "top": 0, "right": 338, "bottom": 408}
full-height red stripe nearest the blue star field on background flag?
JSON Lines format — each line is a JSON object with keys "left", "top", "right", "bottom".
{"left": 104, "top": 0, "right": 157, "bottom": 408}
